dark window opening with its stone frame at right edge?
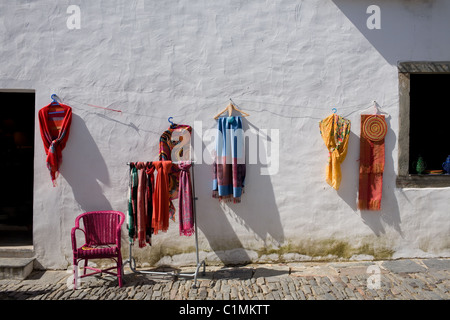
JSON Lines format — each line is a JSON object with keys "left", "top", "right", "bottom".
{"left": 396, "top": 61, "right": 450, "bottom": 188}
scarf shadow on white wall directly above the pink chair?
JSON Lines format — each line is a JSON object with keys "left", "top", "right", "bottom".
{"left": 61, "top": 114, "right": 112, "bottom": 211}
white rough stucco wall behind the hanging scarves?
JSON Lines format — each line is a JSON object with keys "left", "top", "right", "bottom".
{"left": 0, "top": 0, "right": 450, "bottom": 268}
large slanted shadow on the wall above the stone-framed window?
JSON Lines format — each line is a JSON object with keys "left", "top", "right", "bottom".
{"left": 332, "top": 0, "right": 444, "bottom": 65}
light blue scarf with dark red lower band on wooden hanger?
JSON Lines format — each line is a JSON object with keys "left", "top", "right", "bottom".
{"left": 213, "top": 116, "right": 246, "bottom": 203}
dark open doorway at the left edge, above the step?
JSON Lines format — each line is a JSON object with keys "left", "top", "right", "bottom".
{"left": 0, "top": 91, "right": 35, "bottom": 246}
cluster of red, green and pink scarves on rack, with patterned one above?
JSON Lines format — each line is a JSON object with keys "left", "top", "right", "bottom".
{"left": 128, "top": 125, "right": 194, "bottom": 239}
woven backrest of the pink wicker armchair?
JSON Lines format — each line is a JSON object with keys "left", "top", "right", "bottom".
{"left": 76, "top": 211, "right": 125, "bottom": 246}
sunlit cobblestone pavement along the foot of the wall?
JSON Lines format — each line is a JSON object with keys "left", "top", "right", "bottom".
{"left": 0, "top": 259, "right": 450, "bottom": 301}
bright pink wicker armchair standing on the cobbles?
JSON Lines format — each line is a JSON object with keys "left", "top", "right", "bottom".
{"left": 71, "top": 211, "right": 125, "bottom": 289}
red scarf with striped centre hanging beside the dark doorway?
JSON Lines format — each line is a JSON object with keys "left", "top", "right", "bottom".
{"left": 39, "top": 103, "right": 72, "bottom": 186}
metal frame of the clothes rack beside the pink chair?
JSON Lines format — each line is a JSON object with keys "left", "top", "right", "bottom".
{"left": 123, "top": 161, "right": 206, "bottom": 288}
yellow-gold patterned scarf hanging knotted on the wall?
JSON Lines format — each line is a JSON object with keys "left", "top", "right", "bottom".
{"left": 319, "top": 114, "right": 351, "bottom": 190}
